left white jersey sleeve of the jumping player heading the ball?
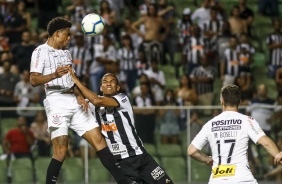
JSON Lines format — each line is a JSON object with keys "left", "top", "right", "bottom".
{"left": 30, "top": 47, "right": 47, "bottom": 73}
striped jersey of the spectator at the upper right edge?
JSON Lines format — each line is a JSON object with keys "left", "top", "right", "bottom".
{"left": 266, "top": 33, "right": 282, "bottom": 66}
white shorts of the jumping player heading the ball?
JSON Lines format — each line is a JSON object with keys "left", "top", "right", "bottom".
{"left": 44, "top": 94, "right": 99, "bottom": 139}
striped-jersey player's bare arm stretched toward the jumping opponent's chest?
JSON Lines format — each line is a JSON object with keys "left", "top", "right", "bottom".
{"left": 69, "top": 68, "right": 119, "bottom": 107}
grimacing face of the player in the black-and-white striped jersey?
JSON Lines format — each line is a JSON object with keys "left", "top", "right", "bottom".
{"left": 100, "top": 75, "right": 120, "bottom": 96}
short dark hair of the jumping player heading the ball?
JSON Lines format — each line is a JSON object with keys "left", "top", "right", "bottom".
{"left": 47, "top": 17, "right": 72, "bottom": 36}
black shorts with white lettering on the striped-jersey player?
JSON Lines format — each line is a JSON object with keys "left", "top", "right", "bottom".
{"left": 118, "top": 153, "right": 173, "bottom": 184}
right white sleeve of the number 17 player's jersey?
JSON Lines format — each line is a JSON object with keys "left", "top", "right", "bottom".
{"left": 246, "top": 117, "right": 265, "bottom": 143}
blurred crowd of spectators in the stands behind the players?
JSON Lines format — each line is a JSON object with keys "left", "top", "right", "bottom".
{"left": 0, "top": 0, "right": 282, "bottom": 181}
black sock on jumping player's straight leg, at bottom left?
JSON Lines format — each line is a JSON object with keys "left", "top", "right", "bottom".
{"left": 46, "top": 158, "right": 63, "bottom": 184}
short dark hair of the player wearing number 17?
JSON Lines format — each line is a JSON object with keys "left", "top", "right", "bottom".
{"left": 221, "top": 84, "right": 241, "bottom": 107}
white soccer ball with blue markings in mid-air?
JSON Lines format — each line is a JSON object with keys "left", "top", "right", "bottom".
{"left": 81, "top": 13, "right": 105, "bottom": 36}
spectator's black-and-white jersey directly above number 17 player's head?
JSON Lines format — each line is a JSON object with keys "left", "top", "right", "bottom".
{"left": 224, "top": 48, "right": 239, "bottom": 77}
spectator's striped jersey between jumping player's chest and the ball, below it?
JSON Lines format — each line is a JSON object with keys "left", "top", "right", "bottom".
{"left": 69, "top": 45, "right": 91, "bottom": 78}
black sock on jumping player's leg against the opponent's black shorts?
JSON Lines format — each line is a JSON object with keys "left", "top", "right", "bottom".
{"left": 97, "top": 147, "right": 130, "bottom": 184}
